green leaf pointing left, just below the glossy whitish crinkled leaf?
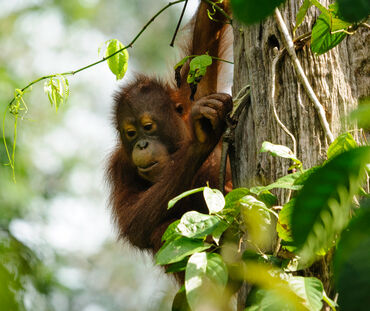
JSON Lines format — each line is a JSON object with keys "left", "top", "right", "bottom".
{"left": 155, "top": 237, "right": 212, "bottom": 265}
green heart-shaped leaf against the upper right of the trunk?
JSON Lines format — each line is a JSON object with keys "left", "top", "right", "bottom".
{"left": 311, "top": 5, "right": 351, "bottom": 54}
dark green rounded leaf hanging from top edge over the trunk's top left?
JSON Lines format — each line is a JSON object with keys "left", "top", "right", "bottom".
{"left": 231, "top": 0, "right": 285, "bottom": 24}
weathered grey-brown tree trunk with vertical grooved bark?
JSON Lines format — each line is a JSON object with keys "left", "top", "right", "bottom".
{"left": 230, "top": 0, "right": 370, "bottom": 310}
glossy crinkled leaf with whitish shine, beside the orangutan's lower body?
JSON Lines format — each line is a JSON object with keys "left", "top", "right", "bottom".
{"left": 177, "top": 211, "right": 222, "bottom": 239}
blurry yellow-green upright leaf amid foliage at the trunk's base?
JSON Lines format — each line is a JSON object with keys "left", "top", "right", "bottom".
{"left": 240, "top": 195, "right": 272, "bottom": 249}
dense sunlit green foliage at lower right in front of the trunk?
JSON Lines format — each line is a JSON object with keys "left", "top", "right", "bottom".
{"left": 156, "top": 133, "right": 370, "bottom": 311}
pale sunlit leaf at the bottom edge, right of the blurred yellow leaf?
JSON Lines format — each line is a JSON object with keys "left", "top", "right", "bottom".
{"left": 288, "top": 276, "right": 324, "bottom": 311}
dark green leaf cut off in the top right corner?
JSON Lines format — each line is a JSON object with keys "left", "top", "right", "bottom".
{"left": 337, "top": 0, "right": 370, "bottom": 22}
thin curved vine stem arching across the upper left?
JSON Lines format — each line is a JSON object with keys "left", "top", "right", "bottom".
{"left": 4, "top": 0, "right": 186, "bottom": 106}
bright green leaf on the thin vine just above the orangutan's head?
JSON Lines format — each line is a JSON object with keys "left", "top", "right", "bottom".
{"left": 104, "top": 39, "right": 129, "bottom": 80}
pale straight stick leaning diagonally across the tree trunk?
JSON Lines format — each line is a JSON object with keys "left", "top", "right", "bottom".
{"left": 275, "top": 8, "right": 334, "bottom": 143}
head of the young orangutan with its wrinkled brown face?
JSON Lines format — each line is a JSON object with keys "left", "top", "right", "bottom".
{"left": 116, "top": 81, "right": 189, "bottom": 183}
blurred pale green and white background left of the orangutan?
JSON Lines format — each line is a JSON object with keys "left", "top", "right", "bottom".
{"left": 0, "top": 0, "right": 197, "bottom": 311}
